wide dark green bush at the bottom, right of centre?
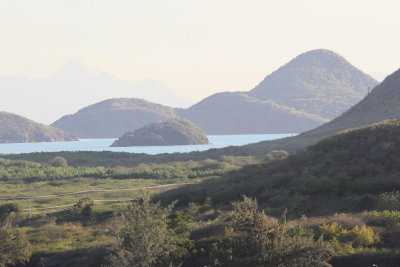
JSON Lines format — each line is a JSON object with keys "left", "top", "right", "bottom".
{"left": 209, "top": 197, "right": 334, "bottom": 267}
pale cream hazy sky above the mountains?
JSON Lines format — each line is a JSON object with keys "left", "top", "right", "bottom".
{"left": 0, "top": 0, "right": 400, "bottom": 100}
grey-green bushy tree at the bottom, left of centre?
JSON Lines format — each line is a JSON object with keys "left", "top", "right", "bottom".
{"left": 109, "top": 192, "right": 193, "bottom": 267}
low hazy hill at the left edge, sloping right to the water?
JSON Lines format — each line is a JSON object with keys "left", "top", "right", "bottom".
{"left": 0, "top": 112, "right": 77, "bottom": 143}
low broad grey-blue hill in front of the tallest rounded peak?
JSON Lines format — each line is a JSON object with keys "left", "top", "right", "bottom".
{"left": 176, "top": 92, "right": 327, "bottom": 134}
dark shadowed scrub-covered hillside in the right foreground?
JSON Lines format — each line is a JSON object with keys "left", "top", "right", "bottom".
{"left": 156, "top": 120, "right": 400, "bottom": 215}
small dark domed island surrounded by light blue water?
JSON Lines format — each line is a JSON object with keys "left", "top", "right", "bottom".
{"left": 111, "top": 119, "right": 208, "bottom": 147}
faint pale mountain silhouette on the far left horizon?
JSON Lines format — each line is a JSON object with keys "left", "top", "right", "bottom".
{"left": 0, "top": 59, "right": 193, "bottom": 123}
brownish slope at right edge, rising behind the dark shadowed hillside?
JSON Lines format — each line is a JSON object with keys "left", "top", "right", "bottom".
{"left": 207, "top": 69, "right": 400, "bottom": 159}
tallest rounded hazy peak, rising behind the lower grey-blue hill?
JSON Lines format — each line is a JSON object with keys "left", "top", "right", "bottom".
{"left": 248, "top": 49, "right": 378, "bottom": 119}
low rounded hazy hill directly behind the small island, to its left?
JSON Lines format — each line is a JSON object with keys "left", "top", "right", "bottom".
{"left": 52, "top": 98, "right": 175, "bottom": 138}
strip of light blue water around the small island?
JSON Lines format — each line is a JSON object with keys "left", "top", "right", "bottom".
{"left": 0, "top": 134, "right": 295, "bottom": 155}
